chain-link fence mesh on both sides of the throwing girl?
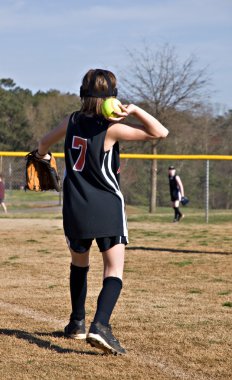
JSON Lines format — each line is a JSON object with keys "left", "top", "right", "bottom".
{"left": 0, "top": 152, "right": 232, "bottom": 217}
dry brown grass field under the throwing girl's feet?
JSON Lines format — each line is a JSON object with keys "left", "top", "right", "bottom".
{"left": 0, "top": 219, "right": 232, "bottom": 380}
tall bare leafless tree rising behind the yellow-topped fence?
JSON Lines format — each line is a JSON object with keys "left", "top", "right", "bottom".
{"left": 120, "top": 44, "right": 209, "bottom": 212}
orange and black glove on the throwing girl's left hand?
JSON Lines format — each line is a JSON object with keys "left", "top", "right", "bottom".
{"left": 25, "top": 150, "right": 60, "bottom": 191}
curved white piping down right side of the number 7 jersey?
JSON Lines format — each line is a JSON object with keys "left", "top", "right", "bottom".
{"left": 101, "top": 148, "right": 128, "bottom": 236}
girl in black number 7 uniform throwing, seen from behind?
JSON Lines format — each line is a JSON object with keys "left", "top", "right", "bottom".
{"left": 37, "top": 69, "right": 168, "bottom": 354}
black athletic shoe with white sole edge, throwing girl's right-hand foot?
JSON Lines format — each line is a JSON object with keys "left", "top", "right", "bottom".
{"left": 86, "top": 322, "right": 126, "bottom": 355}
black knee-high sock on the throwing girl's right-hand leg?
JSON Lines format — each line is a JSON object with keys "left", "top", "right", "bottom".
{"left": 94, "top": 277, "right": 122, "bottom": 326}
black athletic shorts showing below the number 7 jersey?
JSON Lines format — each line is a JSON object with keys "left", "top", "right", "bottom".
{"left": 66, "top": 236, "right": 128, "bottom": 253}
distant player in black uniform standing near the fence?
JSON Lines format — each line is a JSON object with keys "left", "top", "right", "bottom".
{"left": 168, "top": 166, "right": 184, "bottom": 222}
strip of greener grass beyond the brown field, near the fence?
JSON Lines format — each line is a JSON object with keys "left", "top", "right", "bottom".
{"left": 0, "top": 190, "right": 232, "bottom": 224}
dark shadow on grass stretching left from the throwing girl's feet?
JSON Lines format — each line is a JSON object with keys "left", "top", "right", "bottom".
{"left": 0, "top": 329, "right": 99, "bottom": 356}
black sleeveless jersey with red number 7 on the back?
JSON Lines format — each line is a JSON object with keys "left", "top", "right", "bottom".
{"left": 63, "top": 112, "right": 128, "bottom": 239}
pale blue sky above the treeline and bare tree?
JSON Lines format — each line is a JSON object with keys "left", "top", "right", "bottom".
{"left": 0, "top": 0, "right": 232, "bottom": 109}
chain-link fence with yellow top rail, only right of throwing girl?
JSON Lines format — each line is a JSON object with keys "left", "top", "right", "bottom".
{"left": 121, "top": 155, "right": 232, "bottom": 210}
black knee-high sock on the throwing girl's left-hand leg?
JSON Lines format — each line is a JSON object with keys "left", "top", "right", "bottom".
{"left": 70, "top": 264, "right": 89, "bottom": 321}
